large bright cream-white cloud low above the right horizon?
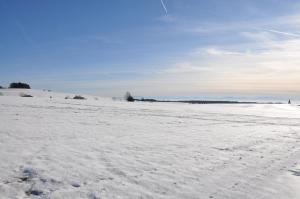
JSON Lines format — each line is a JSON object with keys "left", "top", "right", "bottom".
{"left": 156, "top": 35, "right": 300, "bottom": 94}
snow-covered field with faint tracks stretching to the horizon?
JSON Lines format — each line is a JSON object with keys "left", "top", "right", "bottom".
{"left": 0, "top": 89, "right": 300, "bottom": 199}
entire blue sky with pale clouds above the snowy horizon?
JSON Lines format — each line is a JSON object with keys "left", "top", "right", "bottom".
{"left": 0, "top": 0, "right": 300, "bottom": 96}
